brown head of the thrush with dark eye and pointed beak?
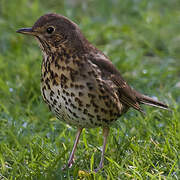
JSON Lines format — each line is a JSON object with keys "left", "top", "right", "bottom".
{"left": 17, "top": 13, "right": 88, "bottom": 53}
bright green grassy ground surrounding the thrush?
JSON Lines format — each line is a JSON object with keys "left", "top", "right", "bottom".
{"left": 0, "top": 0, "right": 180, "bottom": 180}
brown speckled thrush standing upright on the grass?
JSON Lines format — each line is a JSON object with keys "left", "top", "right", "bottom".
{"left": 16, "top": 13, "right": 169, "bottom": 172}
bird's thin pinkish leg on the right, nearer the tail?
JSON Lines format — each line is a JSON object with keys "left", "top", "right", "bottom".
{"left": 95, "top": 127, "right": 109, "bottom": 172}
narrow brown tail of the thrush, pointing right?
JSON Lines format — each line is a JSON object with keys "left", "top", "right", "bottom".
{"left": 135, "top": 92, "right": 169, "bottom": 110}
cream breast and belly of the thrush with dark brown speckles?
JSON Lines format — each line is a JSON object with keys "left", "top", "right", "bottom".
{"left": 41, "top": 52, "right": 120, "bottom": 127}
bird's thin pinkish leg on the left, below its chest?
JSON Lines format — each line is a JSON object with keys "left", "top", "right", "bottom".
{"left": 63, "top": 128, "right": 83, "bottom": 170}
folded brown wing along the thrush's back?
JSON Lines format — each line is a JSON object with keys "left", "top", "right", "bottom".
{"left": 90, "top": 56, "right": 143, "bottom": 112}
